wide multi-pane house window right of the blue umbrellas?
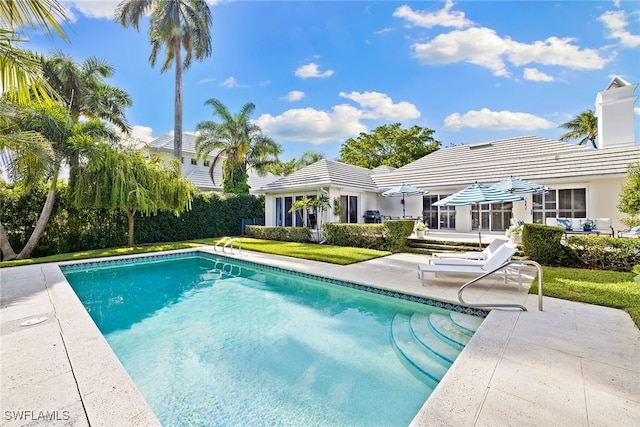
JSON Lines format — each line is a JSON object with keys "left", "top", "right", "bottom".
{"left": 533, "top": 188, "right": 587, "bottom": 224}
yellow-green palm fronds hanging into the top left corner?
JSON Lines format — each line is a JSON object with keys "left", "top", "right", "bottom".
{"left": 0, "top": 0, "right": 68, "bottom": 104}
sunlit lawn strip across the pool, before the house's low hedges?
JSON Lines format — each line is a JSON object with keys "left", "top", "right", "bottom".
{"left": 195, "top": 237, "right": 391, "bottom": 265}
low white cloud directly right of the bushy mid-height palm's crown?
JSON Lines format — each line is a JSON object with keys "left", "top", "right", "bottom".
{"left": 255, "top": 105, "right": 367, "bottom": 144}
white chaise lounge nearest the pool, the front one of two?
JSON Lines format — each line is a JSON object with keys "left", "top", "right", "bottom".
{"left": 418, "top": 244, "right": 522, "bottom": 291}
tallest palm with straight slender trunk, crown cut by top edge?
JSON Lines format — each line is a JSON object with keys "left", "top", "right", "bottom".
{"left": 115, "top": 0, "right": 211, "bottom": 169}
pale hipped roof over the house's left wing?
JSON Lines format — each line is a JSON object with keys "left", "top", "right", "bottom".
{"left": 263, "top": 159, "right": 378, "bottom": 192}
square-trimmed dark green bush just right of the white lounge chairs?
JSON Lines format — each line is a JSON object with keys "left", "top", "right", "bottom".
{"left": 522, "top": 224, "right": 574, "bottom": 266}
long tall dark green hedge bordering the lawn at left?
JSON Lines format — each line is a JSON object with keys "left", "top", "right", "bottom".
{"left": 0, "top": 182, "right": 264, "bottom": 257}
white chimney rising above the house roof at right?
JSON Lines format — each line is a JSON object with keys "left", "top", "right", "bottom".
{"left": 596, "top": 76, "right": 638, "bottom": 149}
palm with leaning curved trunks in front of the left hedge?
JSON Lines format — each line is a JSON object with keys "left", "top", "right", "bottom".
{"left": 0, "top": 104, "right": 117, "bottom": 260}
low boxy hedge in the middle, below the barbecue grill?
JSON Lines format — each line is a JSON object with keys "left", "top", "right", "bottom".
{"left": 322, "top": 222, "right": 385, "bottom": 249}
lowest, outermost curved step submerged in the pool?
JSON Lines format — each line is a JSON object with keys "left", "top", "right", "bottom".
{"left": 391, "top": 314, "right": 450, "bottom": 382}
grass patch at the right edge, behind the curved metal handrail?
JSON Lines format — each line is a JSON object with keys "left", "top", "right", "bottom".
{"left": 529, "top": 267, "right": 640, "bottom": 328}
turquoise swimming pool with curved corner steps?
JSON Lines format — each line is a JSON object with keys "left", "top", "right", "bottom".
{"left": 63, "top": 253, "right": 478, "bottom": 425}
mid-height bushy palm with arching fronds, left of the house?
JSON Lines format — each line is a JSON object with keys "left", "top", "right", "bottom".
{"left": 196, "top": 98, "right": 282, "bottom": 192}
